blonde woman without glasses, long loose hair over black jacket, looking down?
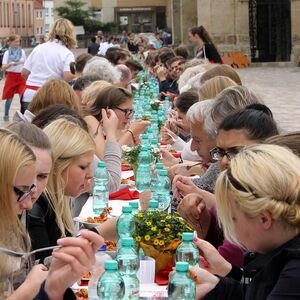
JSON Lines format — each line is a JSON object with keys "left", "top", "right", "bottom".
{"left": 28, "top": 119, "right": 95, "bottom": 259}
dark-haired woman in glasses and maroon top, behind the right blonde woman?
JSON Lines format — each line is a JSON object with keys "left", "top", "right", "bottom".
{"left": 175, "top": 104, "right": 278, "bottom": 266}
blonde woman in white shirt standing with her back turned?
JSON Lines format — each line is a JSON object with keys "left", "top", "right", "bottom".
{"left": 22, "top": 18, "right": 77, "bottom": 111}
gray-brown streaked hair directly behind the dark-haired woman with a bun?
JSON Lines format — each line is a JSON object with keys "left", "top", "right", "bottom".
{"left": 211, "top": 85, "right": 263, "bottom": 124}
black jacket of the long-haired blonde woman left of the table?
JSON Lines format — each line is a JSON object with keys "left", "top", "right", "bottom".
{"left": 27, "top": 194, "right": 71, "bottom": 261}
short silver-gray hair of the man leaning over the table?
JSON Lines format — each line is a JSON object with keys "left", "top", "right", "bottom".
{"left": 186, "top": 99, "right": 217, "bottom": 137}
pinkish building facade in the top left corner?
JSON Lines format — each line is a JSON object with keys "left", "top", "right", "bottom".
{"left": 0, "top": 0, "right": 34, "bottom": 38}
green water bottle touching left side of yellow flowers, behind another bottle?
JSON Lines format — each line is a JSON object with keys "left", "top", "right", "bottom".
{"left": 117, "top": 206, "right": 134, "bottom": 249}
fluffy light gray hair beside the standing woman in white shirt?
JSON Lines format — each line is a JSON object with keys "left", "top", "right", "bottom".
{"left": 82, "top": 57, "right": 121, "bottom": 83}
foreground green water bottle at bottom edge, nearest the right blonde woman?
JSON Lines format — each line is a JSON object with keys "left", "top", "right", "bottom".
{"left": 168, "top": 262, "right": 196, "bottom": 300}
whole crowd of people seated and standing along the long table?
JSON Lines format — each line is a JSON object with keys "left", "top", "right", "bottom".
{"left": 0, "top": 18, "right": 300, "bottom": 300}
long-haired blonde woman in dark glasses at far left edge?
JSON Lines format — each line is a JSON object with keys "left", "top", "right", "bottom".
{"left": 0, "top": 129, "right": 47, "bottom": 299}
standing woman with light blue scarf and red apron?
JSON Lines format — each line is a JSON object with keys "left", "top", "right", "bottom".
{"left": 1, "top": 34, "right": 26, "bottom": 122}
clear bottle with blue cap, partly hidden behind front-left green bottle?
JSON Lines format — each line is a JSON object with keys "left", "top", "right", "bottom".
{"left": 89, "top": 245, "right": 112, "bottom": 300}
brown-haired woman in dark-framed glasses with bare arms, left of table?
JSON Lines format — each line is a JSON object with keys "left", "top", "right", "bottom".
{"left": 85, "top": 86, "right": 150, "bottom": 158}
